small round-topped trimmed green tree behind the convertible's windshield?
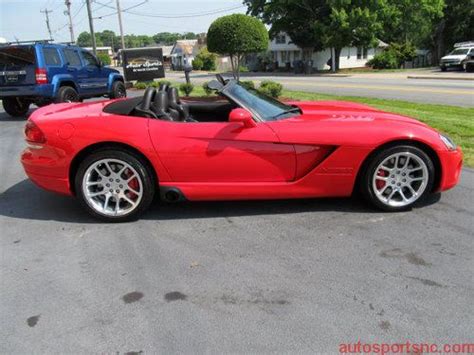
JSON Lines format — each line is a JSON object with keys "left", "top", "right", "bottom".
{"left": 207, "top": 14, "right": 268, "bottom": 80}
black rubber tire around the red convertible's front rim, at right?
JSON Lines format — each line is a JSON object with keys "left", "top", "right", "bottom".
{"left": 359, "top": 145, "right": 435, "bottom": 212}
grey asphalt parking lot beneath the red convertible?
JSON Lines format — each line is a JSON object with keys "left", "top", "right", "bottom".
{"left": 0, "top": 105, "right": 474, "bottom": 354}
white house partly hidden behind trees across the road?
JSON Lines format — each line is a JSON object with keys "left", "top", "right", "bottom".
{"left": 269, "top": 33, "right": 388, "bottom": 70}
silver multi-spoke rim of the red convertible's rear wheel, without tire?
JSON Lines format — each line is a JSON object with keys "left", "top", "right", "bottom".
{"left": 82, "top": 159, "right": 143, "bottom": 217}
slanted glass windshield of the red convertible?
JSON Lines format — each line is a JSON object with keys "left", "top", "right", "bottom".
{"left": 225, "top": 83, "right": 301, "bottom": 121}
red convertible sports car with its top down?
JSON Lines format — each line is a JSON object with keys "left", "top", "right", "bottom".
{"left": 21, "top": 75, "right": 462, "bottom": 221}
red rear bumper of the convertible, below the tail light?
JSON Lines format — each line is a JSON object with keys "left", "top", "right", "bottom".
{"left": 21, "top": 147, "right": 72, "bottom": 195}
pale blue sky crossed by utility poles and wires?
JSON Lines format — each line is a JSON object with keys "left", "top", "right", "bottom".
{"left": 0, "top": 0, "right": 246, "bottom": 42}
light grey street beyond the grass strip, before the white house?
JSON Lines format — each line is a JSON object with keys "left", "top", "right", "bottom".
{"left": 166, "top": 71, "right": 474, "bottom": 107}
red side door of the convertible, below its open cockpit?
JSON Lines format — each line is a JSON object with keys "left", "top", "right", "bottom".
{"left": 149, "top": 119, "right": 296, "bottom": 183}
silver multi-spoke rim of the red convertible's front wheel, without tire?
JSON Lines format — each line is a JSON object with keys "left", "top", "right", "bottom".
{"left": 372, "top": 152, "right": 429, "bottom": 207}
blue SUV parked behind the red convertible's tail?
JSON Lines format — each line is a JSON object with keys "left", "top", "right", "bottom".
{"left": 0, "top": 41, "right": 127, "bottom": 116}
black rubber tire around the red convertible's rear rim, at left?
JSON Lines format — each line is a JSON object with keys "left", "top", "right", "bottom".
{"left": 74, "top": 148, "right": 156, "bottom": 222}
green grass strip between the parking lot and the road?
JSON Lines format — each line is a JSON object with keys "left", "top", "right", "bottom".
{"left": 154, "top": 85, "right": 474, "bottom": 167}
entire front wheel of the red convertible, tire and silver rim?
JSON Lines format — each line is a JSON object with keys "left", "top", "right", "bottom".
{"left": 361, "top": 145, "right": 435, "bottom": 212}
